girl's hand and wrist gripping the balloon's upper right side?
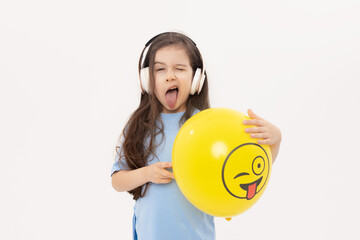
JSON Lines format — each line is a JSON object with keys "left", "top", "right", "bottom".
{"left": 243, "top": 109, "right": 282, "bottom": 163}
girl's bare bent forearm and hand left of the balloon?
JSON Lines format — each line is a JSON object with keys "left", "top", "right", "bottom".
{"left": 111, "top": 162, "right": 174, "bottom": 192}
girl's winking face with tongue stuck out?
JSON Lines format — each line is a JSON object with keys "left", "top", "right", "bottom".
{"left": 154, "top": 45, "right": 193, "bottom": 113}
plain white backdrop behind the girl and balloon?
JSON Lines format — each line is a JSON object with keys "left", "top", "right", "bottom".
{"left": 0, "top": 0, "right": 360, "bottom": 240}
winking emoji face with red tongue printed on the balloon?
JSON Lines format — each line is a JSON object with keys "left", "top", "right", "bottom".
{"left": 222, "top": 143, "right": 270, "bottom": 200}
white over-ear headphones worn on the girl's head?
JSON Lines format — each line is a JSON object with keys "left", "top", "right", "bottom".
{"left": 139, "top": 32, "right": 206, "bottom": 95}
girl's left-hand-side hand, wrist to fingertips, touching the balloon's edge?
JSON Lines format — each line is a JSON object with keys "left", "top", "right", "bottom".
{"left": 145, "top": 162, "right": 174, "bottom": 184}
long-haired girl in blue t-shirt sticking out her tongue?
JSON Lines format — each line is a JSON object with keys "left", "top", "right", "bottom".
{"left": 111, "top": 32, "right": 281, "bottom": 240}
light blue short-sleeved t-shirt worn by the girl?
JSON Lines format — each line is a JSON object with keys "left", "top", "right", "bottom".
{"left": 111, "top": 111, "right": 215, "bottom": 240}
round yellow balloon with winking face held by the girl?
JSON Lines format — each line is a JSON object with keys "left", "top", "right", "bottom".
{"left": 172, "top": 108, "right": 272, "bottom": 218}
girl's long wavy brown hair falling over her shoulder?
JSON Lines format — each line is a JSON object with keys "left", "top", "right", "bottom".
{"left": 116, "top": 32, "right": 210, "bottom": 200}
